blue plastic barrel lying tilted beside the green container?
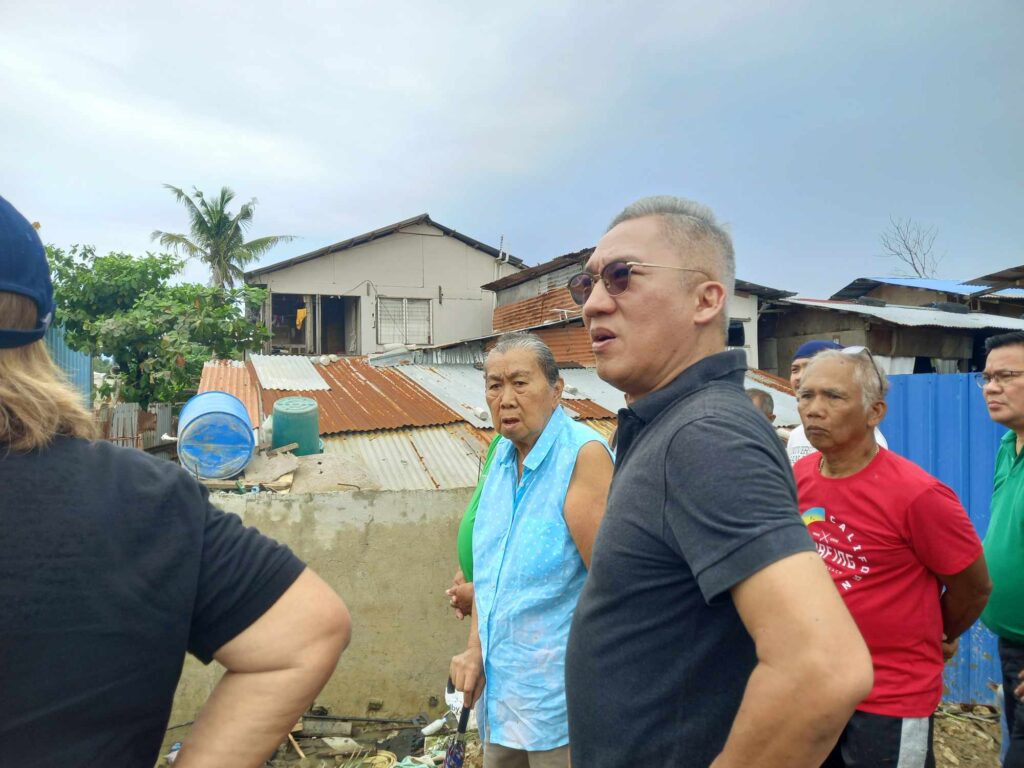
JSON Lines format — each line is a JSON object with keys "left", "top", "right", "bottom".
{"left": 178, "top": 392, "right": 256, "bottom": 480}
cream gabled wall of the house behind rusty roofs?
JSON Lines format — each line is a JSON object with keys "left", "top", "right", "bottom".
{"left": 260, "top": 224, "right": 518, "bottom": 354}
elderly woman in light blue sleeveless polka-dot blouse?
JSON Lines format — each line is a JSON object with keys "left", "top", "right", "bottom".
{"left": 452, "top": 334, "right": 612, "bottom": 768}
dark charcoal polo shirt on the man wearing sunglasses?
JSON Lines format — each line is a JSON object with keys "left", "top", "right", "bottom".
{"left": 565, "top": 352, "right": 814, "bottom": 768}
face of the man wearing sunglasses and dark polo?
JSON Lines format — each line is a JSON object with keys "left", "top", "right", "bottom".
{"left": 583, "top": 216, "right": 695, "bottom": 399}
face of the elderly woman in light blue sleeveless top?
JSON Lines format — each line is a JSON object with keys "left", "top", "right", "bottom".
{"left": 484, "top": 349, "right": 562, "bottom": 450}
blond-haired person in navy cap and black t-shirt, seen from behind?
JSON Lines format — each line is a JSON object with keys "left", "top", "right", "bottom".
{"left": 0, "top": 198, "right": 349, "bottom": 768}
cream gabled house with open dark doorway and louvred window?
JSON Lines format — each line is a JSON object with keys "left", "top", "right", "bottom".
{"left": 246, "top": 214, "right": 523, "bottom": 355}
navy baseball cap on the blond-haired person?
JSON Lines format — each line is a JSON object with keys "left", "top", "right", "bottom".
{"left": 0, "top": 197, "right": 53, "bottom": 349}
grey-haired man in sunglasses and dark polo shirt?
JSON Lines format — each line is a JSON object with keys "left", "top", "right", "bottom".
{"left": 566, "top": 197, "right": 871, "bottom": 768}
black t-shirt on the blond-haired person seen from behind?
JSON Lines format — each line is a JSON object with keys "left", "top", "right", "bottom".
{"left": 0, "top": 437, "right": 304, "bottom": 768}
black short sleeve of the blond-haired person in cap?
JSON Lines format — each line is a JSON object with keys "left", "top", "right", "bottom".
{"left": 182, "top": 487, "right": 305, "bottom": 664}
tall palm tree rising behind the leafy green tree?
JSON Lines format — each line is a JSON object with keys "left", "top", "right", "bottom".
{"left": 152, "top": 184, "right": 295, "bottom": 288}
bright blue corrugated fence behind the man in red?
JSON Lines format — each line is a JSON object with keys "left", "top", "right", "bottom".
{"left": 882, "top": 374, "right": 1006, "bottom": 709}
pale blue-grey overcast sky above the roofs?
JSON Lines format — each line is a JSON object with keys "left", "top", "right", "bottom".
{"left": 0, "top": 0, "right": 1024, "bottom": 297}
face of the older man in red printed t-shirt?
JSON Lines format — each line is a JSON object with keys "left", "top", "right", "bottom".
{"left": 797, "top": 358, "right": 886, "bottom": 453}
